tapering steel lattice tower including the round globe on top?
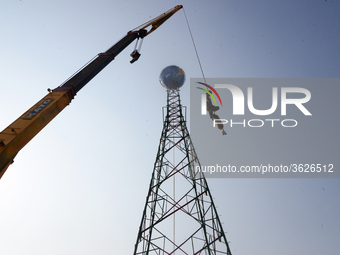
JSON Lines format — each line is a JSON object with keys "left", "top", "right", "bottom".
{"left": 134, "top": 66, "right": 231, "bottom": 255}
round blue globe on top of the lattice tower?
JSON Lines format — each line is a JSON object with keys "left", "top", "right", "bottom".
{"left": 159, "top": 65, "right": 185, "bottom": 90}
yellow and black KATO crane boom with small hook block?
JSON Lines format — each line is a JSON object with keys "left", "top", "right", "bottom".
{"left": 0, "top": 5, "right": 182, "bottom": 178}
